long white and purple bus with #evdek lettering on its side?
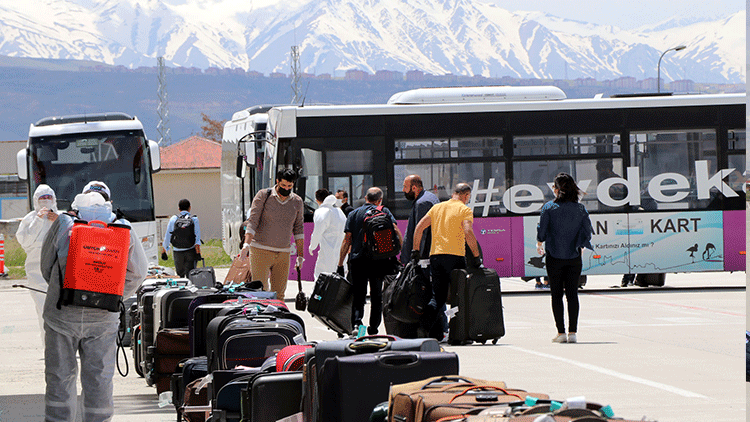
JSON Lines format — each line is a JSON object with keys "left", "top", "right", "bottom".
{"left": 219, "top": 87, "right": 746, "bottom": 282}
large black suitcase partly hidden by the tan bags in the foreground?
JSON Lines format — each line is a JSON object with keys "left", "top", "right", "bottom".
{"left": 319, "top": 352, "right": 458, "bottom": 422}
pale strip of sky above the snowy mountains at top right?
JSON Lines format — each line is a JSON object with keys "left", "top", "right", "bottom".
{"left": 494, "top": 0, "right": 746, "bottom": 29}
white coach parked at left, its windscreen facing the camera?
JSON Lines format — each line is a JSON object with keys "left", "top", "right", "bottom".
{"left": 16, "top": 113, "right": 161, "bottom": 264}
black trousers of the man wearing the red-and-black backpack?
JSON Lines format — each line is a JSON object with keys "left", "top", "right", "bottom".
{"left": 349, "top": 258, "right": 391, "bottom": 334}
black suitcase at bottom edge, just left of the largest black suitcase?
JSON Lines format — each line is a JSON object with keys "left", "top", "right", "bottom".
{"left": 240, "top": 371, "right": 303, "bottom": 422}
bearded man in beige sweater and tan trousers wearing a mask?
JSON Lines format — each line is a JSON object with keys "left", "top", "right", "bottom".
{"left": 240, "top": 169, "right": 305, "bottom": 300}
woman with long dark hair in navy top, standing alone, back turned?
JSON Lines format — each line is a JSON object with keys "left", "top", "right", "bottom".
{"left": 536, "top": 173, "right": 594, "bottom": 343}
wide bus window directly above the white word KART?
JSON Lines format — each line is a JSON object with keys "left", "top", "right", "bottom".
{"left": 630, "top": 130, "right": 722, "bottom": 211}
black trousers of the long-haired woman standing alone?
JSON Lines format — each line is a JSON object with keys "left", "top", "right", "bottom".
{"left": 547, "top": 254, "right": 583, "bottom": 333}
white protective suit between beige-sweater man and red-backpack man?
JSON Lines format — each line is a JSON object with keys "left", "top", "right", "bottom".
{"left": 309, "top": 195, "right": 346, "bottom": 280}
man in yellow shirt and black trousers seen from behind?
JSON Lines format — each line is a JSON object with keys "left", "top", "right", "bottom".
{"left": 411, "top": 183, "right": 482, "bottom": 340}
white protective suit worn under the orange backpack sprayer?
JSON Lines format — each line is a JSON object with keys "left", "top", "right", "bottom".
{"left": 41, "top": 192, "right": 148, "bottom": 422}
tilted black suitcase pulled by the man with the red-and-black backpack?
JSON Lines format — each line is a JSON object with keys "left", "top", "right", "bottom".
{"left": 307, "top": 273, "right": 354, "bottom": 335}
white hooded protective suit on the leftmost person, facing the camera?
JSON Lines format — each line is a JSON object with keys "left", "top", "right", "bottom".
{"left": 16, "top": 185, "right": 59, "bottom": 333}
